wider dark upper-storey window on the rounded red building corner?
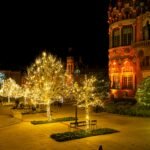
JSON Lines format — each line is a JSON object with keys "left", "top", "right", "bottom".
{"left": 122, "top": 25, "right": 133, "bottom": 46}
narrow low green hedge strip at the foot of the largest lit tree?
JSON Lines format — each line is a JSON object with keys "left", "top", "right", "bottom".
{"left": 31, "top": 117, "right": 75, "bottom": 125}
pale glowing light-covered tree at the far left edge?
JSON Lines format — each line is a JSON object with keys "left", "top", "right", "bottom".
{"left": 0, "top": 78, "right": 22, "bottom": 102}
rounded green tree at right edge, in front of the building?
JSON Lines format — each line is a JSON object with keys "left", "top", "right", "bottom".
{"left": 135, "top": 76, "right": 150, "bottom": 105}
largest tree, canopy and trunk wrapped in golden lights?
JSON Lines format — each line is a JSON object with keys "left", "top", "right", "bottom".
{"left": 26, "top": 52, "right": 65, "bottom": 120}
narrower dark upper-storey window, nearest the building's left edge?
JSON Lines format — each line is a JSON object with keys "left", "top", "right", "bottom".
{"left": 113, "top": 28, "right": 120, "bottom": 47}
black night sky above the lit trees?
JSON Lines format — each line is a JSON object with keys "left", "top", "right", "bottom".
{"left": 0, "top": 0, "right": 109, "bottom": 68}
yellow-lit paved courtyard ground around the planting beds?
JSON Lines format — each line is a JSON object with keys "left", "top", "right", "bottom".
{"left": 0, "top": 105, "right": 150, "bottom": 150}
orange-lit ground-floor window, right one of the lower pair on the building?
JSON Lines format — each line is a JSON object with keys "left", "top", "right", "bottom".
{"left": 122, "top": 76, "right": 133, "bottom": 89}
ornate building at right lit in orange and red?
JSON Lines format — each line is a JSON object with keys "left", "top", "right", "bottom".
{"left": 108, "top": 0, "right": 150, "bottom": 98}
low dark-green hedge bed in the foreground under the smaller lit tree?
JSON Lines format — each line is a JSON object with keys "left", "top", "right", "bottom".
{"left": 50, "top": 128, "right": 119, "bottom": 142}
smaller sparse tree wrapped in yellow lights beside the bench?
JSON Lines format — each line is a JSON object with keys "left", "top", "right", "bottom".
{"left": 70, "top": 76, "right": 102, "bottom": 128}
